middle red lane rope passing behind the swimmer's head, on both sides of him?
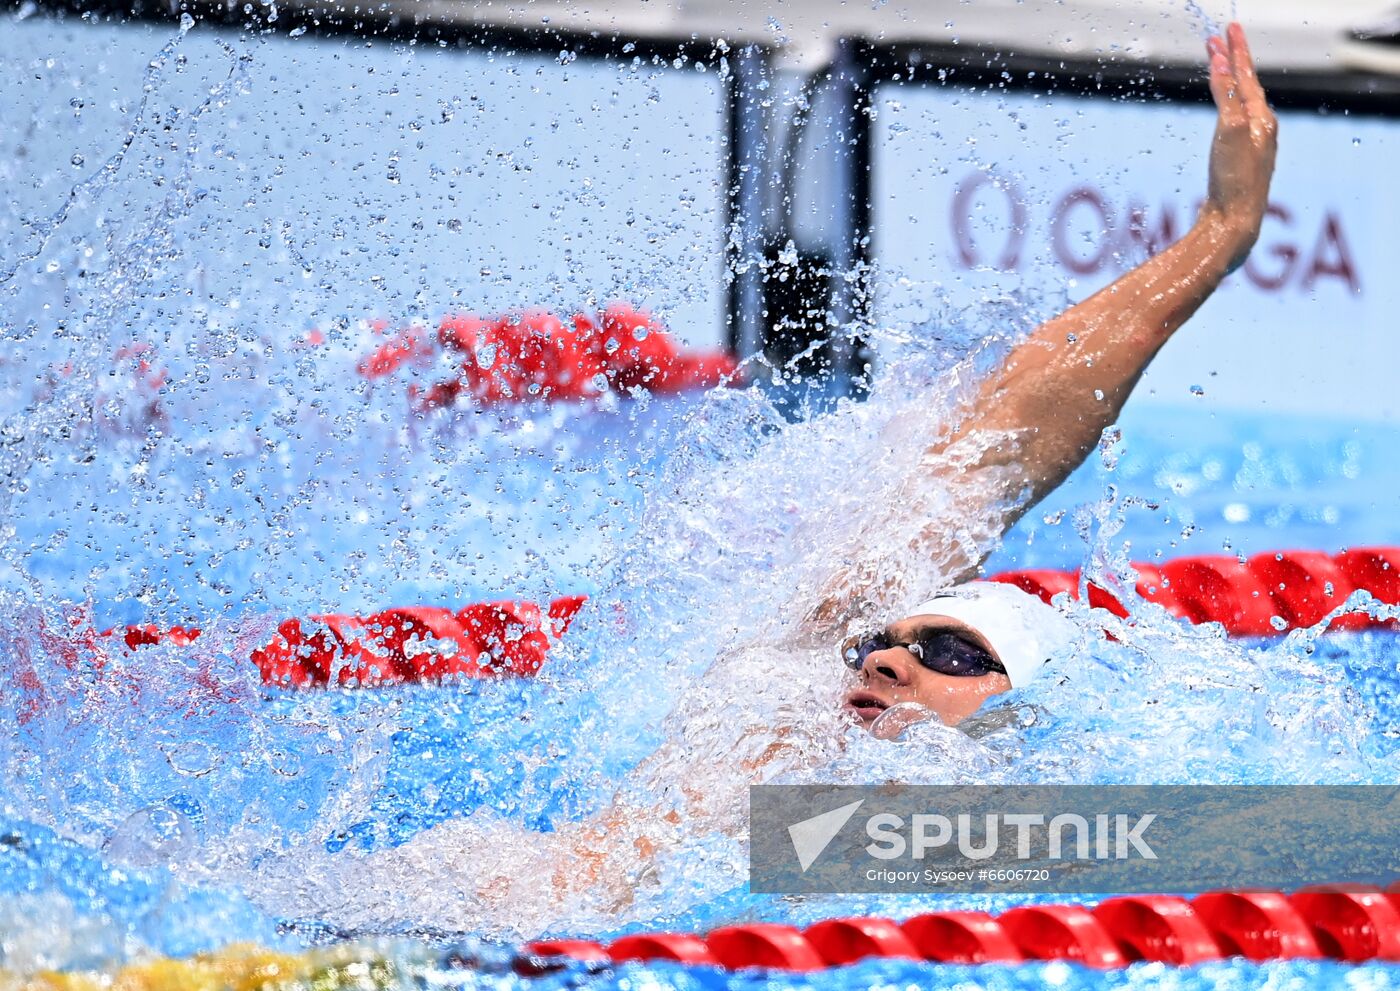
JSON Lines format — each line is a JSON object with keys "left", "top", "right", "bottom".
{"left": 92, "top": 547, "right": 1400, "bottom": 689}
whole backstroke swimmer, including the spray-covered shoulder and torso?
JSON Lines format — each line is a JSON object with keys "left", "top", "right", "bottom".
{"left": 298, "top": 24, "right": 1277, "bottom": 936}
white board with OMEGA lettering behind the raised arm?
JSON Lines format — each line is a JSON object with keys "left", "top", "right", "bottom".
{"left": 872, "top": 84, "right": 1400, "bottom": 420}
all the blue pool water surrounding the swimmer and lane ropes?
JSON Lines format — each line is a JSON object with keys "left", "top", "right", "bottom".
{"left": 0, "top": 9, "right": 1400, "bottom": 991}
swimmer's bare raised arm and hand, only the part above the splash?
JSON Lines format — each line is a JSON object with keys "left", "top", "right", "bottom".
{"left": 952, "top": 24, "right": 1278, "bottom": 512}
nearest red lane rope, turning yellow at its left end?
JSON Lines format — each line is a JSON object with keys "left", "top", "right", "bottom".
{"left": 8, "top": 885, "right": 1400, "bottom": 991}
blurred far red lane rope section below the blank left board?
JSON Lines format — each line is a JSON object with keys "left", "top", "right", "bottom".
{"left": 350, "top": 304, "right": 738, "bottom": 410}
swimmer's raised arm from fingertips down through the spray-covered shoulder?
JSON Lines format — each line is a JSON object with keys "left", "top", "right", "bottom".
{"left": 799, "top": 24, "right": 1278, "bottom": 635}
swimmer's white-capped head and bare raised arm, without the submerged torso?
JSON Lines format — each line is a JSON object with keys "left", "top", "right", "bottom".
{"left": 825, "top": 24, "right": 1278, "bottom": 735}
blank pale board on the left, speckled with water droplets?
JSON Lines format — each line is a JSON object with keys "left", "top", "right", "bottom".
{"left": 0, "top": 15, "right": 728, "bottom": 347}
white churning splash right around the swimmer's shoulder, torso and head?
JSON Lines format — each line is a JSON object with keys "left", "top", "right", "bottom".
{"left": 224, "top": 330, "right": 1393, "bottom": 935}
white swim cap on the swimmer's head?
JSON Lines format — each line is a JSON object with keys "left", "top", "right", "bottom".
{"left": 910, "top": 581, "right": 1078, "bottom": 689}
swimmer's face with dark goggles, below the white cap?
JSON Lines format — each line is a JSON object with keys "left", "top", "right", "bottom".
{"left": 843, "top": 613, "right": 1011, "bottom": 736}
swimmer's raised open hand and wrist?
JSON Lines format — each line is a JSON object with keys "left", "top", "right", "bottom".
{"left": 1201, "top": 24, "right": 1278, "bottom": 269}
